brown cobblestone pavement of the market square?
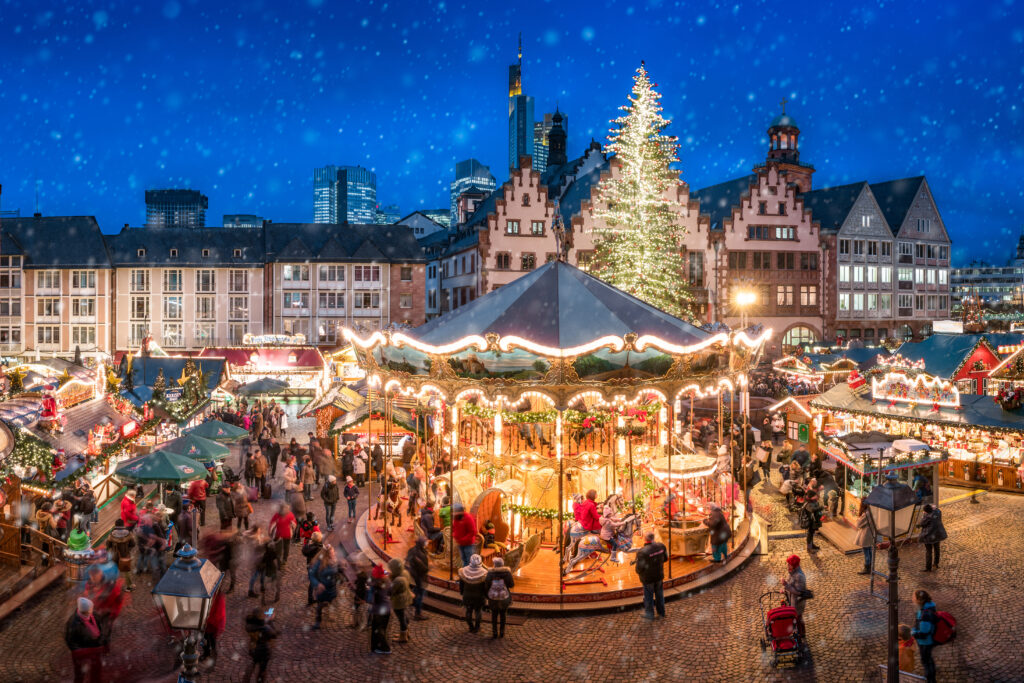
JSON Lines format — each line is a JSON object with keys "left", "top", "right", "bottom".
{"left": 0, "top": 464, "right": 1024, "bottom": 682}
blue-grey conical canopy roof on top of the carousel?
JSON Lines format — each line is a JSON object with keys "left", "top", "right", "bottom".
{"left": 407, "top": 261, "right": 713, "bottom": 349}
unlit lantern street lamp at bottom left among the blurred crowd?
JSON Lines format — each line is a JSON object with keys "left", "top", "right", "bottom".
{"left": 153, "top": 544, "right": 224, "bottom": 682}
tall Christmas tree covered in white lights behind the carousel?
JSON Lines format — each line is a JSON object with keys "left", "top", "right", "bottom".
{"left": 591, "top": 61, "right": 690, "bottom": 318}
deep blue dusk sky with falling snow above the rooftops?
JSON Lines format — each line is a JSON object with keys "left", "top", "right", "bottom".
{"left": 0, "top": 0, "right": 1024, "bottom": 261}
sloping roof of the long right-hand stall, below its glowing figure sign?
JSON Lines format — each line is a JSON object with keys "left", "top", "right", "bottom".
{"left": 810, "top": 384, "right": 1024, "bottom": 432}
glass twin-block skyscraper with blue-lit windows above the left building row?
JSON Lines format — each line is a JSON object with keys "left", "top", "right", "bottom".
{"left": 313, "top": 166, "right": 377, "bottom": 223}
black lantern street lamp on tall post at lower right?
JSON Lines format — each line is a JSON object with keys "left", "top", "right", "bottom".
{"left": 864, "top": 472, "right": 918, "bottom": 683}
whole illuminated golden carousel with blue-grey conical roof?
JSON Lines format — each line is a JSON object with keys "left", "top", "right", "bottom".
{"left": 345, "top": 261, "right": 770, "bottom": 609}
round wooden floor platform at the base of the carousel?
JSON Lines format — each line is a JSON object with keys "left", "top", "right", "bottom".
{"left": 355, "top": 511, "right": 764, "bottom": 615}
